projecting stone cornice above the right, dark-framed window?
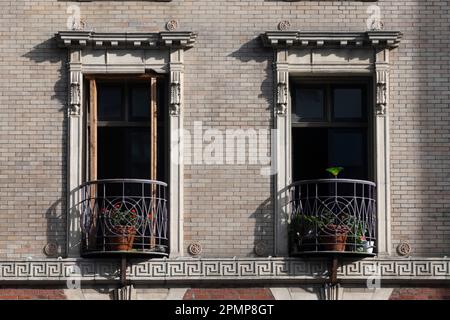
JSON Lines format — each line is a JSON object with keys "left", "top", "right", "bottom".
{"left": 261, "top": 31, "right": 402, "bottom": 48}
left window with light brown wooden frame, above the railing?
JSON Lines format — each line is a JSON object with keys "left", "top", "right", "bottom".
{"left": 87, "top": 77, "right": 168, "bottom": 181}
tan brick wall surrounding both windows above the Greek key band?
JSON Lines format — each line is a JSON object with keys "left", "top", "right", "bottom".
{"left": 0, "top": 0, "right": 450, "bottom": 259}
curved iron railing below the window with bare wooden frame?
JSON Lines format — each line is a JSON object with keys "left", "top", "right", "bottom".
{"left": 79, "top": 179, "right": 169, "bottom": 256}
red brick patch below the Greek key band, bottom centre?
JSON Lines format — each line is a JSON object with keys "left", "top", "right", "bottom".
{"left": 183, "top": 288, "right": 275, "bottom": 300}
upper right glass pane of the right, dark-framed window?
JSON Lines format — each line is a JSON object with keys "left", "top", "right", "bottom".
{"left": 333, "top": 88, "right": 363, "bottom": 119}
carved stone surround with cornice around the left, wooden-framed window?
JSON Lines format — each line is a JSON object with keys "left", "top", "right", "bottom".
{"left": 55, "top": 31, "right": 197, "bottom": 258}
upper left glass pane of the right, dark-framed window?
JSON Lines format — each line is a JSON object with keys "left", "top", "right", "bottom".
{"left": 295, "top": 88, "right": 324, "bottom": 121}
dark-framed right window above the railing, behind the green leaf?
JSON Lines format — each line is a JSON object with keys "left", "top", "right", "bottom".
{"left": 291, "top": 78, "right": 372, "bottom": 181}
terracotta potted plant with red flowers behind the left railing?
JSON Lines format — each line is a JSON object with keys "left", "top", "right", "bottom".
{"left": 109, "top": 203, "right": 137, "bottom": 251}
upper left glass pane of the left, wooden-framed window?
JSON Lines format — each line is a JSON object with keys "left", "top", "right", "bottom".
{"left": 97, "top": 84, "right": 123, "bottom": 121}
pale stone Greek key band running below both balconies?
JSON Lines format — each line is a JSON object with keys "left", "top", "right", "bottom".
{"left": 0, "top": 258, "right": 450, "bottom": 283}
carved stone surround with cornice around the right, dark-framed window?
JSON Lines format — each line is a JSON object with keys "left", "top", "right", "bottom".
{"left": 261, "top": 30, "right": 402, "bottom": 256}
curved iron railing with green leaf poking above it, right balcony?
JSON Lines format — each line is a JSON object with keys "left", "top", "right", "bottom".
{"left": 288, "top": 179, "right": 376, "bottom": 255}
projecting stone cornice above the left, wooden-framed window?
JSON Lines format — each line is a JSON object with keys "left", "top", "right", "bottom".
{"left": 56, "top": 31, "right": 197, "bottom": 48}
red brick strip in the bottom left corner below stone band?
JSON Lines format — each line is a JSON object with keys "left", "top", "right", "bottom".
{"left": 0, "top": 288, "right": 66, "bottom": 300}
